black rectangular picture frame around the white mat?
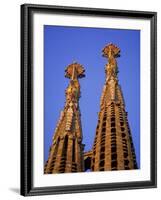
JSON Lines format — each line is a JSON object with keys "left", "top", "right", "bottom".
{"left": 21, "top": 4, "right": 157, "bottom": 196}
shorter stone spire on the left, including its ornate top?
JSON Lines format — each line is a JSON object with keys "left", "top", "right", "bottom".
{"left": 44, "top": 62, "right": 85, "bottom": 174}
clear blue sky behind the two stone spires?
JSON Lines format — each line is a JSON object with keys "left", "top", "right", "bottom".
{"left": 44, "top": 25, "right": 140, "bottom": 169}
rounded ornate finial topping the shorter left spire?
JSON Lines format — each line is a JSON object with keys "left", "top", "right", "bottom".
{"left": 65, "top": 62, "right": 85, "bottom": 80}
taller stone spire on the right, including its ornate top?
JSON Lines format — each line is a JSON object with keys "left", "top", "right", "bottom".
{"left": 91, "top": 44, "right": 137, "bottom": 171}
